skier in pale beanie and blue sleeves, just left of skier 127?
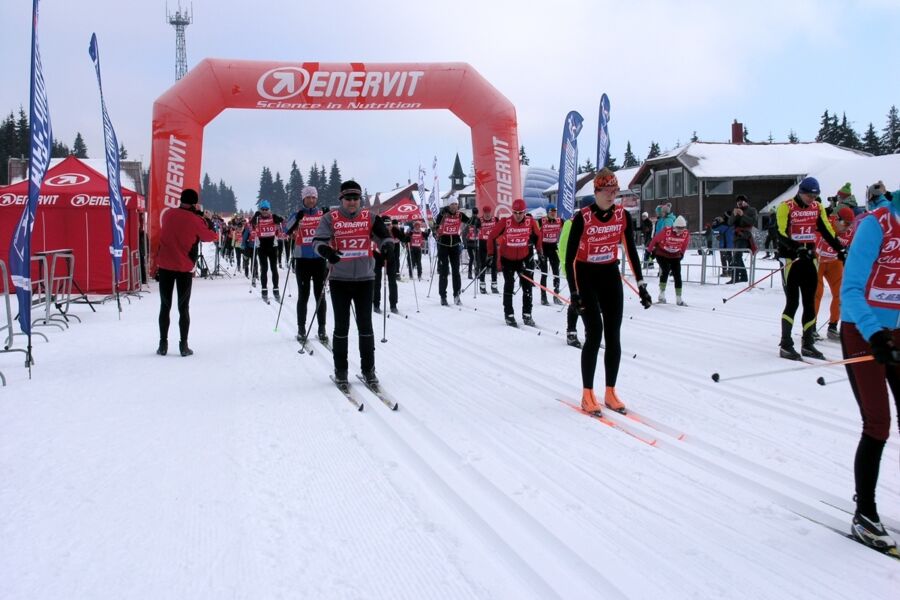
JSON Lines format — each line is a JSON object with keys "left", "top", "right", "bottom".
{"left": 286, "top": 185, "right": 328, "bottom": 343}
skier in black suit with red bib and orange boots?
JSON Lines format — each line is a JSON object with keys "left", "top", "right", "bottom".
{"left": 566, "top": 168, "right": 653, "bottom": 413}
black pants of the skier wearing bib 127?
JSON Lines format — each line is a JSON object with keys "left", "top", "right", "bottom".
{"left": 330, "top": 279, "right": 375, "bottom": 372}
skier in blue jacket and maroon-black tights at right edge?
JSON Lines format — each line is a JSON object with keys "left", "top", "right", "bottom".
{"left": 841, "top": 185, "right": 900, "bottom": 552}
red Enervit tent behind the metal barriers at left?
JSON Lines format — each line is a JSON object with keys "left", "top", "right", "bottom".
{"left": 0, "top": 156, "right": 145, "bottom": 294}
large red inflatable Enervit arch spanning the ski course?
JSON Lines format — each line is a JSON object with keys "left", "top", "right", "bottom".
{"left": 149, "top": 59, "right": 522, "bottom": 270}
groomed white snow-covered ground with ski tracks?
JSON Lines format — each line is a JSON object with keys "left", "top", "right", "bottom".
{"left": 0, "top": 248, "right": 900, "bottom": 600}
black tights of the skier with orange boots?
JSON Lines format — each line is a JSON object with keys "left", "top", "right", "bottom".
{"left": 576, "top": 263, "right": 622, "bottom": 389}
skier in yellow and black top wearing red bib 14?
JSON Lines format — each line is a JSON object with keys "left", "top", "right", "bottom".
{"left": 775, "top": 177, "right": 847, "bottom": 360}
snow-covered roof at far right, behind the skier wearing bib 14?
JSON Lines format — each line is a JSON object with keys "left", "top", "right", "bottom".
{"left": 760, "top": 154, "right": 900, "bottom": 212}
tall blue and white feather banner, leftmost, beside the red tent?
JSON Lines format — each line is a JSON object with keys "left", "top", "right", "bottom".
{"left": 9, "top": 0, "right": 53, "bottom": 338}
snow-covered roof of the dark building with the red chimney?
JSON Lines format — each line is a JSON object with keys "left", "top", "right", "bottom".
{"left": 635, "top": 142, "right": 870, "bottom": 185}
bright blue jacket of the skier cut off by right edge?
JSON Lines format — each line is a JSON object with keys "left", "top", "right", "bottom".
{"left": 841, "top": 205, "right": 900, "bottom": 340}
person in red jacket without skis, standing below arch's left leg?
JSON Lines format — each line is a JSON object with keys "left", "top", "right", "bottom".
{"left": 156, "top": 189, "right": 218, "bottom": 356}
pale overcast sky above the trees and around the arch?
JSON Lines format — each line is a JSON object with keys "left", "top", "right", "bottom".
{"left": 0, "top": 0, "right": 900, "bottom": 208}
